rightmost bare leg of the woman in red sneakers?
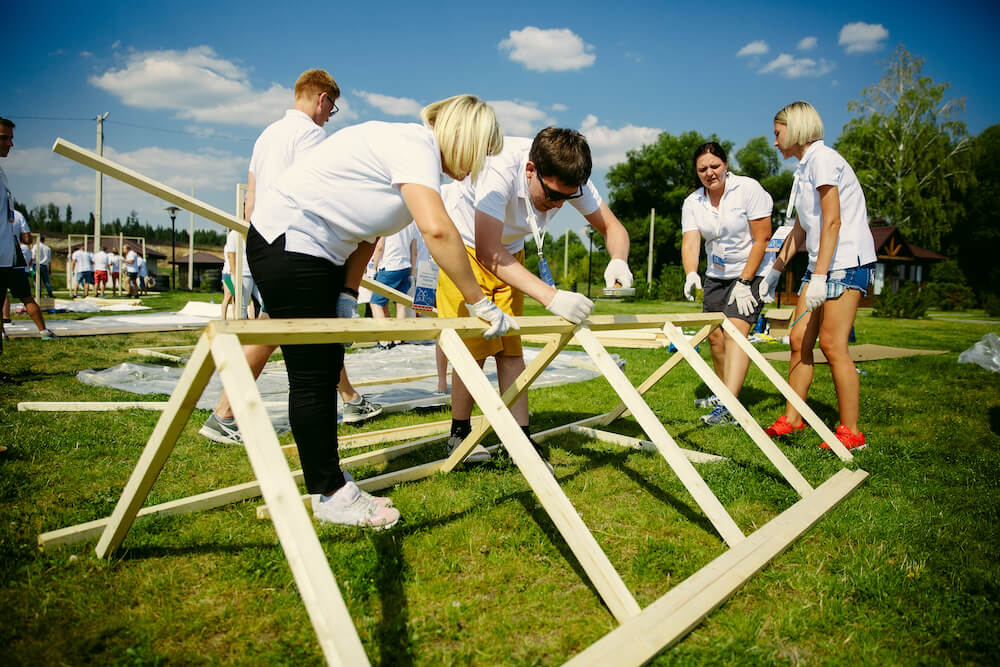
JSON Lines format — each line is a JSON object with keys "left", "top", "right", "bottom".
{"left": 819, "top": 289, "right": 861, "bottom": 434}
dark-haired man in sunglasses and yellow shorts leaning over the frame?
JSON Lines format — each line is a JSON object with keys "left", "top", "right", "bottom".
{"left": 437, "top": 127, "right": 632, "bottom": 468}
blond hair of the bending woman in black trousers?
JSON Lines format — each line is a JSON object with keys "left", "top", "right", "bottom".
{"left": 420, "top": 95, "right": 503, "bottom": 180}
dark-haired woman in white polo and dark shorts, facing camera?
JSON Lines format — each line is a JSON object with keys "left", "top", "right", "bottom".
{"left": 681, "top": 141, "right": 773, "bottom": 426}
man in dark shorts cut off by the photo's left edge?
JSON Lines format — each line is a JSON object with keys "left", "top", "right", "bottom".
{"left": 0, "top": 118, "right": 55, "bottom": 353}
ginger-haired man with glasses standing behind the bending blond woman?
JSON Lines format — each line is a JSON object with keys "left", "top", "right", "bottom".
{"left": 198, "top": 69, "right": 382, "bottom": 443}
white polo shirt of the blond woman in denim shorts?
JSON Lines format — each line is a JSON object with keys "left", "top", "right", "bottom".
{"left": 795, "top": 141, "right": 876, "bottom": 271}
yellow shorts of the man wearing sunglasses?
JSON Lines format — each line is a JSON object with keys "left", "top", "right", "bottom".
{"left": 437, "top": 246, "right": 524, "bottom": 361}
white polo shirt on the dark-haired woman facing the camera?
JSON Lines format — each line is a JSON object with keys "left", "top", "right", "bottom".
{"left": 681, "top": 173, "right": 774, "bottom": 280}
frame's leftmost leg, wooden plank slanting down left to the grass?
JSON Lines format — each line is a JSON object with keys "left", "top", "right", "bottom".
{"left": 96, "top": 336, "right": 214, "bottom": 558}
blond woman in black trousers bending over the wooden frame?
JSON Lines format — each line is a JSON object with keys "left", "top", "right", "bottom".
{"left": 247, "top": 95, "right": 517, "bottom": 528}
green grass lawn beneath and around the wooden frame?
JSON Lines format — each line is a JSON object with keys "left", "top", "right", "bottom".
{"left": 0, "top": 302, "right": 1000, "bottom": 665}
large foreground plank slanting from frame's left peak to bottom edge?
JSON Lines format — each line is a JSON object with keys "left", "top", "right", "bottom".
{"left": 211, "top": 334, "right": 369, "bottom": 666}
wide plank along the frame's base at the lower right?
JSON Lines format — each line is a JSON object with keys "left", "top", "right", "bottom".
{"left": 566, "top": 469, "right": 868, "bottom": 667}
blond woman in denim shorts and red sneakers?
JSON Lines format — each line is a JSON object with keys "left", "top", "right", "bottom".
{"left": 759, "top": 102, "right": 876, "bottom": 449}
